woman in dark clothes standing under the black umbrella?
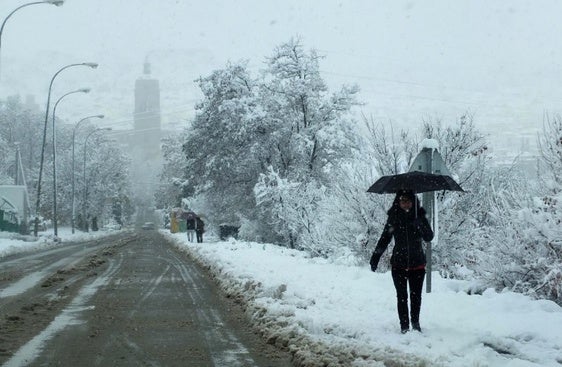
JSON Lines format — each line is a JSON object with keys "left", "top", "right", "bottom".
{"left": 370, "top": 190, "right": 433, "bottom": 334}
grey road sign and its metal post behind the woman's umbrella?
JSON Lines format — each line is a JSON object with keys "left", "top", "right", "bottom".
{"left": 409, "top": 139, "right": 451, "bottom": 293}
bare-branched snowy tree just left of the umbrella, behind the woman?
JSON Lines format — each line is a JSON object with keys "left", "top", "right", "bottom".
{"left": 319, "top": 116, "right": 417, "bottom": 266}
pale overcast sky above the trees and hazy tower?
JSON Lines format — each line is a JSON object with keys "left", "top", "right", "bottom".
{"left": 0, "top": 0, "right": 562, "bottom": 151}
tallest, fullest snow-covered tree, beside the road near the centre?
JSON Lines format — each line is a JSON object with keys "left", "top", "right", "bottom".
{"left": 177, "top": 40, "right": 357, "bottom": 246}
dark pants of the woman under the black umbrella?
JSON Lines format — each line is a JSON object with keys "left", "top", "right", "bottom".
{"left": 392, "top": 269, "right": 425, "bottom": 330}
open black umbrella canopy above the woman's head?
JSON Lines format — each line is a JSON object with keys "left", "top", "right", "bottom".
{"left": 367, "top": 171, "right": 464, "bottom": 194}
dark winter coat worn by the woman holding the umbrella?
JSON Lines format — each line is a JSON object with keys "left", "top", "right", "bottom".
{"left": 370, "top": 196, "right": 433, "bottom": 271}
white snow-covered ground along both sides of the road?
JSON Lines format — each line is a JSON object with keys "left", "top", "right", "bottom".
{"left": 0, "top": 229, "right": 562, "bottom": 367}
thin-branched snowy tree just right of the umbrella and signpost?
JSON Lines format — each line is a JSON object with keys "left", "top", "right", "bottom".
{"left": 421, "top": 114, "right": 490, "bottom": 275}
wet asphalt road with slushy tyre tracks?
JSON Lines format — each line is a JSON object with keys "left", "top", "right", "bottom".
{"left": 0, "top": 231, "right": 291, "bottom": 367}
